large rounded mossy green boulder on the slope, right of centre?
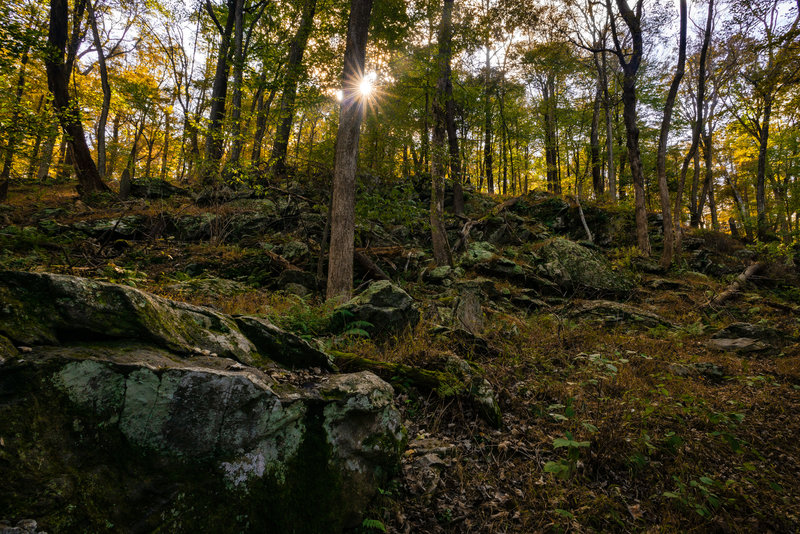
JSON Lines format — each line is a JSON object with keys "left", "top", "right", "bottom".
{"left": 535, "top": 237, "right": 633, "bottom": 296}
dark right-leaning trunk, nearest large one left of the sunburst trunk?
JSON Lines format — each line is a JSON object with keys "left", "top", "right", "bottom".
{"left": 271, "top": 0, "right": 318, "bottom": 177}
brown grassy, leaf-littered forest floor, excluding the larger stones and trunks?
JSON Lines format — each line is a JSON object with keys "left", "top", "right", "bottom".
{"left": 0, "top": 184, "right": 800, "bottom": 533}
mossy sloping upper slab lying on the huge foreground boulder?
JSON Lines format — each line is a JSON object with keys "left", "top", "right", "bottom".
{"left": 0, "top": 271, "right": 258, "bottom": 363}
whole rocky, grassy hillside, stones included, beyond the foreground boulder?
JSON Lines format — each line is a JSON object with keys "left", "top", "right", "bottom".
{"left": 0, "top": 182, "right": 800, "bottom": 532}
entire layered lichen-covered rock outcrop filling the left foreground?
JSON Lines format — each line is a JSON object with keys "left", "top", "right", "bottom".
{"left": 0, "top": 272, "right": 405, "bottom": 532}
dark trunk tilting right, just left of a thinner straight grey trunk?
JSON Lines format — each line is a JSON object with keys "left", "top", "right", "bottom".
{"left": 201, "top": 0, "right": 236, "bottom": 185}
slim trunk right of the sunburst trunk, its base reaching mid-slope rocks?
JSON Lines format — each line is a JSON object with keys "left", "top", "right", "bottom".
{"left": 430, "top": 0, "right": 453, "bottom": 265}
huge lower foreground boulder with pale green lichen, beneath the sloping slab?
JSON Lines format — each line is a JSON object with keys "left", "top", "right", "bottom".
{"left": 0, "top": 348, "right": 405, "bottom": 532}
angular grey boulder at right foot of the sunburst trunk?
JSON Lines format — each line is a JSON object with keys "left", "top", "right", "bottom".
{"left": 331, "top": 280, "right": 419, "bottom": 336}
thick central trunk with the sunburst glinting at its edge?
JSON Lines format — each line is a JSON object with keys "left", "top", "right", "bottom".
{"left": 326, "top": 0, "right": 373, "bottom": 300}
